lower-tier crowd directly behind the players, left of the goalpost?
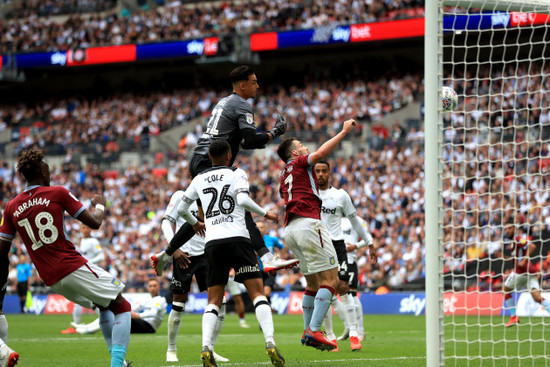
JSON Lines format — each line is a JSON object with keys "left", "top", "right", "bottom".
{"left": 0, "top": 121, "right": 432, "bottom": 296}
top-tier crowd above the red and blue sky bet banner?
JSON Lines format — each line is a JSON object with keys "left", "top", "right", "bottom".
{"left": 0, "top": 0, "right": 424, "bottom": 54}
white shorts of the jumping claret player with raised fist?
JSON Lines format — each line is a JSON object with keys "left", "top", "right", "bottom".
{"left": 285, "top": 217, "right": 338, "bottom": 275}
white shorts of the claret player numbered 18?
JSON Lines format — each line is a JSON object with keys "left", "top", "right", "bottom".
{"left": 51, "top": 262, "right": 124, "bottom": 308}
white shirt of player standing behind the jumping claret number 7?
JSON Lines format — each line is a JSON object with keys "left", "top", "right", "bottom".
{"left": 319, "top": 186, "right": 357, "bottom": 241}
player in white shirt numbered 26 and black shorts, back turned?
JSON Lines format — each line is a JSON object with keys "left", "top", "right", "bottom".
{"left": 178, "top": 140, "right": 285, "bottom": 367}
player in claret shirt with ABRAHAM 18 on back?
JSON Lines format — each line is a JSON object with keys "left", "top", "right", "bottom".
{"left": 0, "top": 150, "right": 131, "bottom": 367}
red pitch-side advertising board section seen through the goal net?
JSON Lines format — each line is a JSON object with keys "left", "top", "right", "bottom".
{"left": 443, "top": 292, "right": 504, "bottom": 316}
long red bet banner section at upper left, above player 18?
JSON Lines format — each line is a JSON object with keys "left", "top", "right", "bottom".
{"left": 67, "top": 45, "right": 136, "bottom": 66}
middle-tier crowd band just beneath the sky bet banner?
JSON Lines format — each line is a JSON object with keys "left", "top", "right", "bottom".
{"left": 0, "top": 73, "right": 422, "bottom": 160}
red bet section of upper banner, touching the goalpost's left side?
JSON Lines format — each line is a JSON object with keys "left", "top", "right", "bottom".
{"left": 350, "top": 18, "right": 424, "bottom": 42}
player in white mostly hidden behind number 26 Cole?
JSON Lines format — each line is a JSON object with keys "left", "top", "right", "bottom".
{"left": 161, "top": 190, "right": 229, "bottom": 362}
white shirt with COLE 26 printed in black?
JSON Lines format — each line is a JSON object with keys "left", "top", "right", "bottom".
{"left": 182, "top": 166, "right": 250, "bottom": 245}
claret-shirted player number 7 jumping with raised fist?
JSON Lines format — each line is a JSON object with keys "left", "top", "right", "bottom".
{"left": 277, "top": 120, "right": 356, "bottom": 350}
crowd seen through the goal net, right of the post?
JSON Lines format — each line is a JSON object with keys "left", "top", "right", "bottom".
{"left": 442, "top": 63, "right": 550, "bottom": 289}
